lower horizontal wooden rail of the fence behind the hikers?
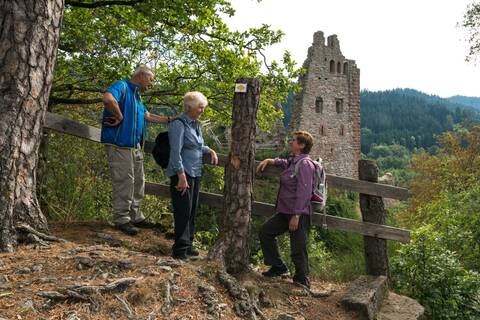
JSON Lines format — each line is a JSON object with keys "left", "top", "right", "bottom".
{"left": 145, "top": 182, "right": 410, "bottom": 243}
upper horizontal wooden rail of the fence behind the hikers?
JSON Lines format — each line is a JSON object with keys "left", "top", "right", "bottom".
{"left": 44, "top": 112, "right": 410, "bottom": 200}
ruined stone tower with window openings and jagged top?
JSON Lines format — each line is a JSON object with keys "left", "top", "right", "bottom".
{"left": 290, "top": 31, "right": 360, "bottom": 178}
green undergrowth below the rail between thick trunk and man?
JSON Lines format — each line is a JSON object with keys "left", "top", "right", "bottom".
{"left": 40, "top": 134, "right": 111, "bottom": 221}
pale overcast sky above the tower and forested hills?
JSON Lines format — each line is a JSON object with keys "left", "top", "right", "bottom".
{"left": 226, "top": 0, "right": 480, "bottom": 97}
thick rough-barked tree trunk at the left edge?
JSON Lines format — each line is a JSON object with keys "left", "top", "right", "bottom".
{"left": 0, "top": 0, "right": 64, "bottom": 252}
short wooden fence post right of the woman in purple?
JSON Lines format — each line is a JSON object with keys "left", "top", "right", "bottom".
{"left": 358, "top": 160, "right": 389, "bottom": 276}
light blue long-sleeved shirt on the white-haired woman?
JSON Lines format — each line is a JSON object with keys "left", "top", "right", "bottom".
{"left": 166, "top": 114, "right": 210, "bottom": 177}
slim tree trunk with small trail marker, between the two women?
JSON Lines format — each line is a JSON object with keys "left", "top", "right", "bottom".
{"left": 209, "top": 79, "right": 260, "bottom": 273}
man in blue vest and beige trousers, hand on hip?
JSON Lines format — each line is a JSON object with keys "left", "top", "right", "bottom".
{"left": 101, "top": 67, "right": 170, "bottom": 235}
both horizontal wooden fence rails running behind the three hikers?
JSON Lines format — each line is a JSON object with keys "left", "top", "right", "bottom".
{"left": 44, "top": 112, "right": 410, "bottom": 243}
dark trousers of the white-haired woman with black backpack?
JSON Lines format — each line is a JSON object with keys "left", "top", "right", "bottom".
{"left": 170, "top": 175, "right": 201, "bottom": 255}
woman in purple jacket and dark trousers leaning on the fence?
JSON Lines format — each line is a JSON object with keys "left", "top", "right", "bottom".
{"left": 257, "top": 131, "right": 315, "bottom": 287}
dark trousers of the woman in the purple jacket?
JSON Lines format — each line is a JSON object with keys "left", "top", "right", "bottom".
{"left": 260, "top": 213, "right": 310, "bottom": 279}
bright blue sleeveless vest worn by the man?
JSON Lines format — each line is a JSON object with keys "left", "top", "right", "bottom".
{"left": 100, "top": 79, "right": 147, "bottom": 148}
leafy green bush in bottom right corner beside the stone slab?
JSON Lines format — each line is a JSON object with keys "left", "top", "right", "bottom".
{"left": 391, "top": 226, "right": 480, "bottom": 320}
